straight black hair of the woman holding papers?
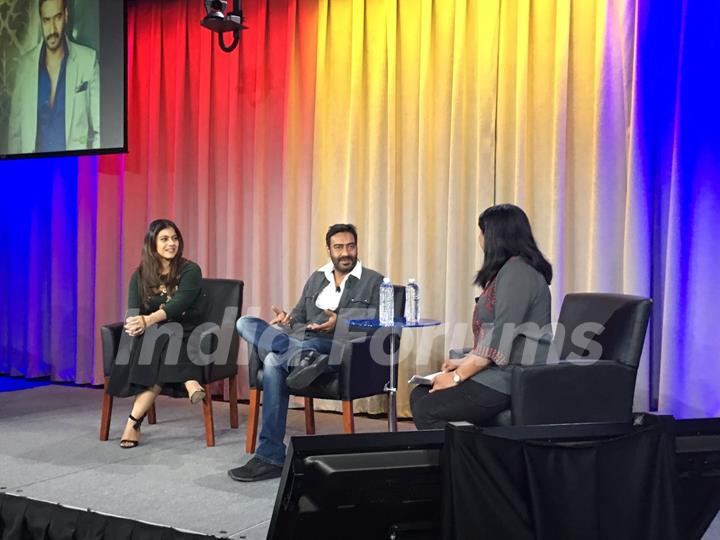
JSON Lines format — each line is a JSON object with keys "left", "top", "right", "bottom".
{"left": 475, "top": 204, "right": 552, "bottom": 288}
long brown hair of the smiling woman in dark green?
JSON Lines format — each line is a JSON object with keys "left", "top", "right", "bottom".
{"left": 137, "top": 219, "right": 185, "bottom": 307}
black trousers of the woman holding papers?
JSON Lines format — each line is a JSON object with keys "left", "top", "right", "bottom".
{"left": 410, "top": 379, "right": 510, "bottom": 429}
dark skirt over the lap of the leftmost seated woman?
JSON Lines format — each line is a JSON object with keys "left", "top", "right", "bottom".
{"left": 108, "top": 321, "right": 203, "bottom": 397}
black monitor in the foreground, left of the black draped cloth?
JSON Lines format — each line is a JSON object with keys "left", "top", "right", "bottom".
{"left": 268, "top": 431, "right": 444, "bottom": 540}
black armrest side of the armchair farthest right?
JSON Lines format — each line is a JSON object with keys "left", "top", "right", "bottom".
{"left": 511, "top": 360, "right": 636, "bottom": 425}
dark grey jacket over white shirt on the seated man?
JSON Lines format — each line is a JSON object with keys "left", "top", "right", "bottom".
{"left": 290, "top": 266, "right": 383, "bottom": 339}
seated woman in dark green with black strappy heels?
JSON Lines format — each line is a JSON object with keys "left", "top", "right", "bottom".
{"left": 108, "top": 219, "right": 205, "bottom": 448}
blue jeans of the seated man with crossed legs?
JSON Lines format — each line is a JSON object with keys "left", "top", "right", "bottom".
{"left": 235, "top": 317, "right": 332, "bottom": 465}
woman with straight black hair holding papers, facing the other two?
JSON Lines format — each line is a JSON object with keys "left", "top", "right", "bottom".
{"left": 410, "top": 204, "right": 552, "bottom": 429}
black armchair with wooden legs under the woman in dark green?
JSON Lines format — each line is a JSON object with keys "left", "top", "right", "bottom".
{"left": 100, "top": 279, "right": 243, "bottom": 446}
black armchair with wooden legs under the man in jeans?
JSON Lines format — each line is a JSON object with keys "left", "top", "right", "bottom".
{"left": 245, "top": 285, "right": 405, "bottom": 454}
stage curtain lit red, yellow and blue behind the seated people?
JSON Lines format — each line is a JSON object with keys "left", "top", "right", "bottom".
{"left": 0, "top": 0, "right": 720, "bottom": 416}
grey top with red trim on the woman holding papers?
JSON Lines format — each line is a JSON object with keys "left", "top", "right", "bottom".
{"left": 472, "top": 257, "right": 552, "bottom": 395}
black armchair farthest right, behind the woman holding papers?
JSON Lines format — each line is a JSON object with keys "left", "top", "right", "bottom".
{"left": 450, "top": 293, "right": 652, "bottom": 425}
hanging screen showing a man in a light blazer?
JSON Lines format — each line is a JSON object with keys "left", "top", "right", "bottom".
{"left": 0, "top": 0, "right": 127, "bottom": 158}
